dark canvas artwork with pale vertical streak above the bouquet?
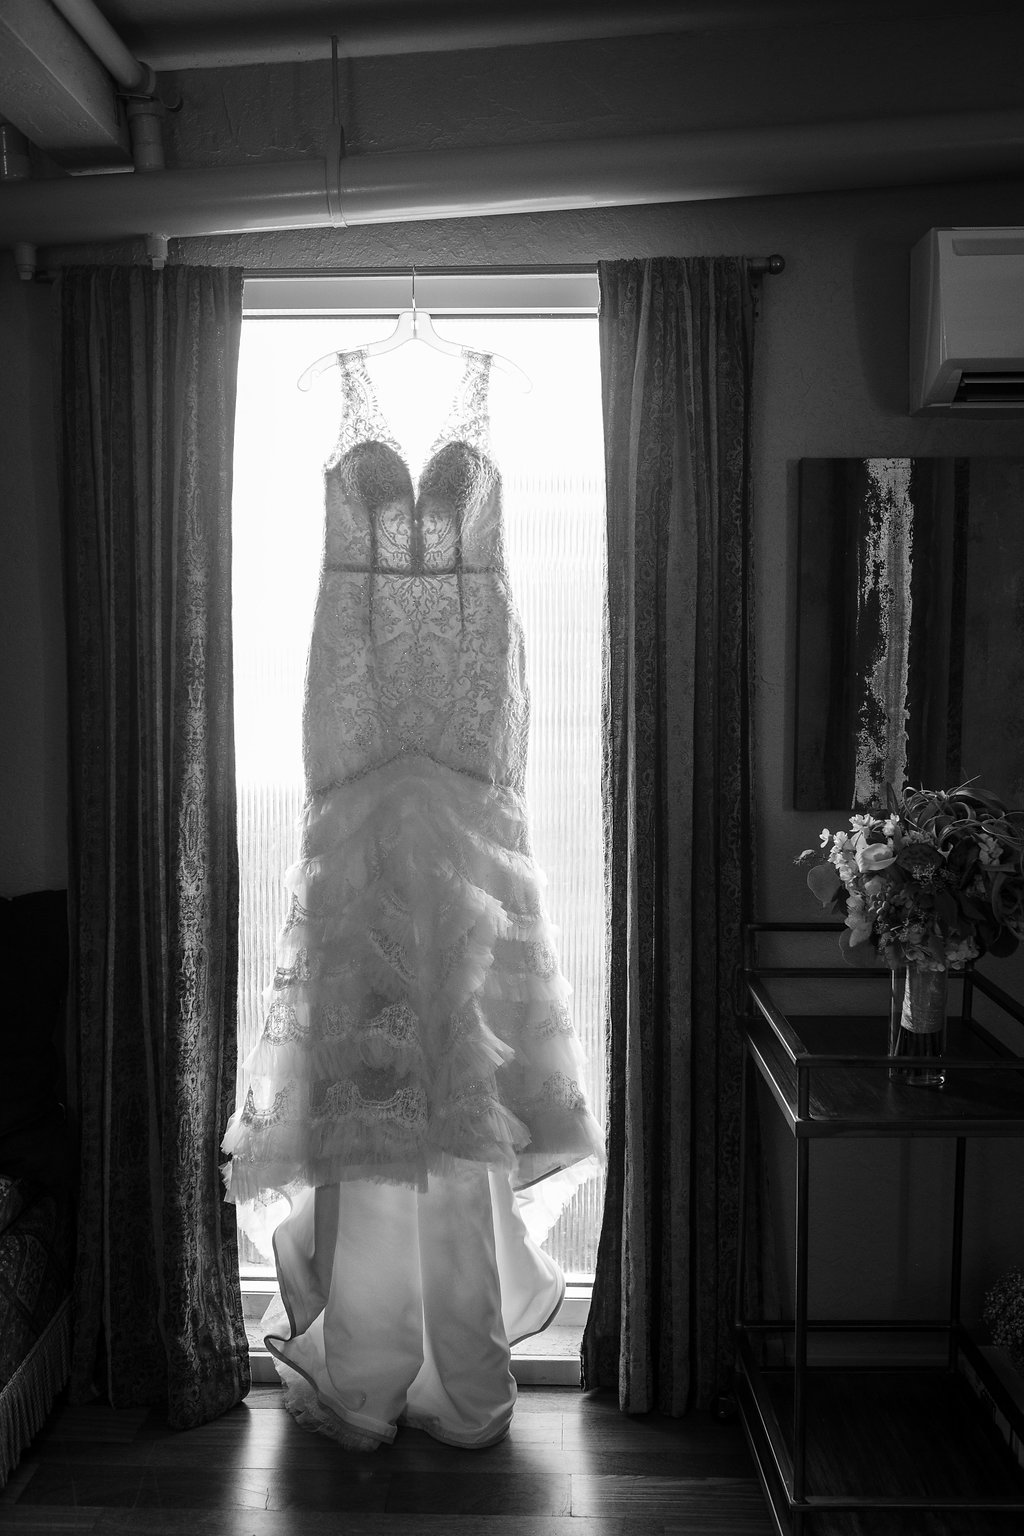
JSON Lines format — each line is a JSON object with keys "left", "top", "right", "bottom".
{"left": 794, "top": 458, "right": 1024, "bottom": 811}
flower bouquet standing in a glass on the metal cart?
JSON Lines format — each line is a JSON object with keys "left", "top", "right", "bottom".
{"left": 797, "top": 783, "right": 1024, "bottom": 1086}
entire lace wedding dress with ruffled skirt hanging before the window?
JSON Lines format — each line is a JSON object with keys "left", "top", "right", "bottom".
{"left": 224, "top": 353, "right": 603, "bottom": 1447}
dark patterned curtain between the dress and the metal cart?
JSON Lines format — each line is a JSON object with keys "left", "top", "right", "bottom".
{"left": 583, "top": 258, "right": 752, "bottom": 1413}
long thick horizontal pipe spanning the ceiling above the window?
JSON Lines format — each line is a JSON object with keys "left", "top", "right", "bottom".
{"left": 0, "top": 112, "right": 1024, "bottom": 246}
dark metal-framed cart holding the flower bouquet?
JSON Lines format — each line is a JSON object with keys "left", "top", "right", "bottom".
{"left": 735, "top": 923, "right": 1024, "bottom": 1536}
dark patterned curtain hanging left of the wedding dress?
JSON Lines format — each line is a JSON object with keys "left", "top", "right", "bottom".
{"left": 58, "top": 267, "right": 249, "bottom": 1427}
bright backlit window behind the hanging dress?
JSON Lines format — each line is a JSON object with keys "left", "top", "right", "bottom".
{"left": 233, "top": 273, "right": 605, "bottom": 1279}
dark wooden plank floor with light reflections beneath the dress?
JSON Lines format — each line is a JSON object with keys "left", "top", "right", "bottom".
{"left": 0, "top": 1387, "right": 774, "bottom": 1536}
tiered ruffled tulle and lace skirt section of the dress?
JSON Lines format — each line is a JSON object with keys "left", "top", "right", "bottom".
{"left": 224, "top": 754, "right": 603, "bottom": 1201}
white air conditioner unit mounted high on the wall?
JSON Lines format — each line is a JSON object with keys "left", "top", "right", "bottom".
{"left": 910, "top": 229, "right": 1024, "bottom": 416}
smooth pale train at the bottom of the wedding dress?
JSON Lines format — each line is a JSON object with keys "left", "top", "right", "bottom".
{"left": 256, "top": 1163, "right": 565, "bottom": 1450}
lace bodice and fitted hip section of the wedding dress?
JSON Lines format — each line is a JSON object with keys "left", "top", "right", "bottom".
{"left": 304, "top": 352, "right": 528, "bottom": 793}
